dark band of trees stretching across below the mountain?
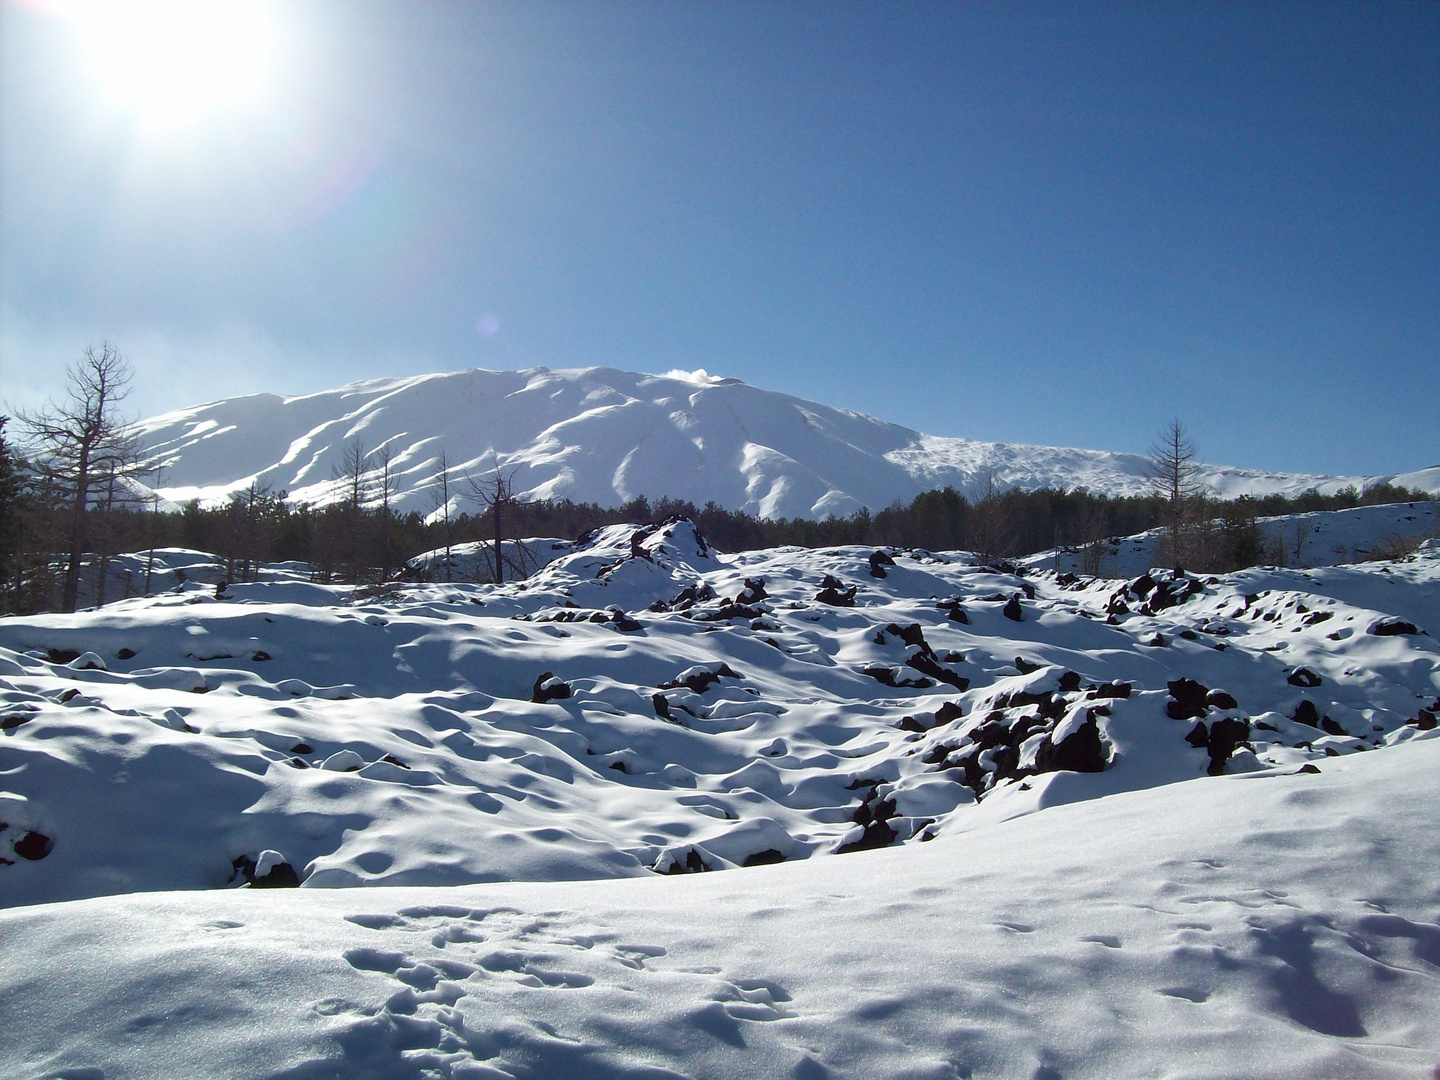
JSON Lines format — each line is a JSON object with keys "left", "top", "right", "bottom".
{"left": 0, "top": 351, "right": 1430, "bottom": 613}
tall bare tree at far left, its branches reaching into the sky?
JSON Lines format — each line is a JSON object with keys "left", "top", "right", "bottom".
{"left": 17, "top": 341, "right": 140, "bottom": 612}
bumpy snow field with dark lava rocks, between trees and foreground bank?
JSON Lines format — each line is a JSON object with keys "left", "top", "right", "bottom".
{"left": 0, "top": 521, "right": 1440, "bottom": 904}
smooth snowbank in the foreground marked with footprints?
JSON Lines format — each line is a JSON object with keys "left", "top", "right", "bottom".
{"left": 0, "top": 739, "right": 1440, "bottom": 1080}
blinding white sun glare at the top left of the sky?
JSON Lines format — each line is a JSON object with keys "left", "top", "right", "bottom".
{"left": 66, "top": 0, "right": 272, "bottom": 124}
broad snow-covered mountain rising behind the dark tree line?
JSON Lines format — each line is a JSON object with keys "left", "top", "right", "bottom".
{"left": 135, "top": 367, "right": 1440, "bottom": 517}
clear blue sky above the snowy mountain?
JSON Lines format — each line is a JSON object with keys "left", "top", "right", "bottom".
{"left": 0, "top": 0, "right": 1440, "bottom": 474}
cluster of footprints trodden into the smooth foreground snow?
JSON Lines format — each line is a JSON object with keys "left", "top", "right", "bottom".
{"left": 321, "top": 904, "right": 796, "bottom": 1080}
